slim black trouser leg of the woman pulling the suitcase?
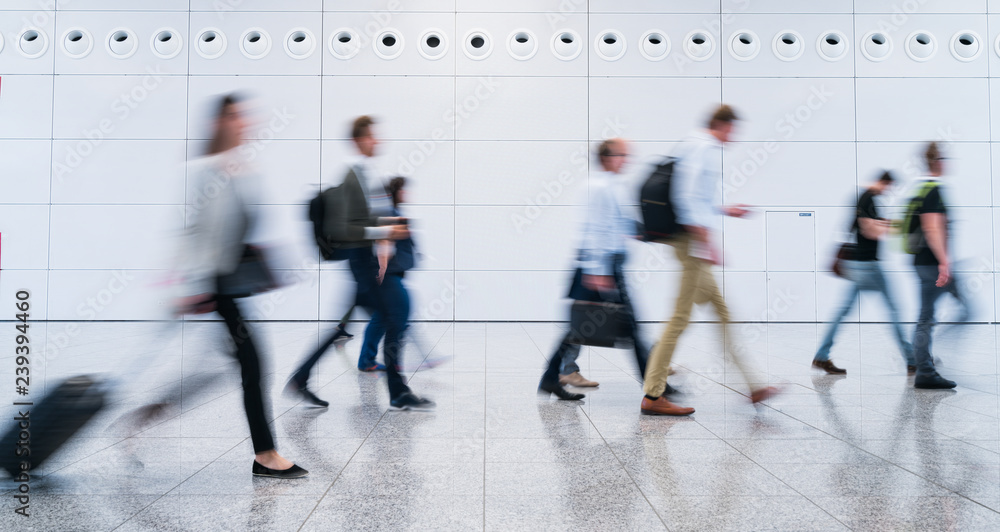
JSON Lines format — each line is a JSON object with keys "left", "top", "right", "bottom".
{"left": 216, "top": 295, "right": 274, "bottom": 453}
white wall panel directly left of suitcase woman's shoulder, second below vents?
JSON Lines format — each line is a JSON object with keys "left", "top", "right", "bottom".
{"left": 52, "top": 140, "right": 185, "bottom": 205}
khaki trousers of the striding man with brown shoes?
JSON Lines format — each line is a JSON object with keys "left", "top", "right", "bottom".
{"left": 643, "top": 234, "right": 751, "bottom": 397}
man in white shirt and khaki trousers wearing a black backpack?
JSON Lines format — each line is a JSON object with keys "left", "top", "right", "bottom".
{"left": 640, "top": 105, "right": 777, "bottom": 415}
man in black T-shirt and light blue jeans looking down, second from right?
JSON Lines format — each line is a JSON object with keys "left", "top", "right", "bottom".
{"left": 812, "top": 172, "right": 916, "bottom": 375}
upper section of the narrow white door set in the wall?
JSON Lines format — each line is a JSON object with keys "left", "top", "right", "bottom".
{"left": 765, "top": 211, "right": 816, "bottom": 272}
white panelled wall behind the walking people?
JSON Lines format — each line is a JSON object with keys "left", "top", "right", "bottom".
{"left": 0, "top": 4, "right": 1000, "bottom": 322}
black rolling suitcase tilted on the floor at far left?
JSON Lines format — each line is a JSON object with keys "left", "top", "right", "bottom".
{"left": 0, "top": 375, "right": 107, "bottom": 477}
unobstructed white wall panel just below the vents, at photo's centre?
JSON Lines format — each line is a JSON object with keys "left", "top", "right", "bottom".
{"left": 453, "top": 76, "right": 587, "bottom": 140}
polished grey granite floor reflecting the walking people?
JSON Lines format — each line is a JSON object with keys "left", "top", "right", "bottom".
{"left": 0, "top": 323, "right": 1000, "bottom": 531}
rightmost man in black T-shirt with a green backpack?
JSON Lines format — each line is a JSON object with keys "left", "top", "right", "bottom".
{"left": 903, "top": 142, "right": 965, "bottom": 389}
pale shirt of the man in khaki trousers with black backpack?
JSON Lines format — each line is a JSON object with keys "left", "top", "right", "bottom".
{"left": 671, "top": 129, "right": 722, "bottom": 229}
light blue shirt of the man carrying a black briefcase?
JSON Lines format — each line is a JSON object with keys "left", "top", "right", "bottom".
{"left": 580, "top": 171, "right": 636, "bottom": 275}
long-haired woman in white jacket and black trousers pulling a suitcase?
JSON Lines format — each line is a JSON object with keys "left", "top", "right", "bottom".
{"left": 180, "top": 95, "right": 308, "bottom": 478}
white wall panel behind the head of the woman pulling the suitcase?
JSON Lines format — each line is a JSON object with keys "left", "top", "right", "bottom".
{"left": 188, "top": 76, "right": 320, "bottom": 140}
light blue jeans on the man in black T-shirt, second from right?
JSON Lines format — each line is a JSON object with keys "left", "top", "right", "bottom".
{"left": 814, "top": 260, "right": 915, "bottom": 366}
